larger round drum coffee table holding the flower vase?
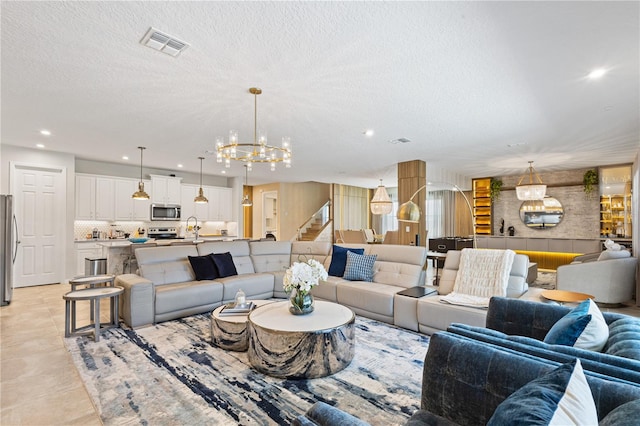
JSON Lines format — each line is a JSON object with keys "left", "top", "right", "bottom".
{"left": 248, "top": 301, "right": 355, "bottom": 379}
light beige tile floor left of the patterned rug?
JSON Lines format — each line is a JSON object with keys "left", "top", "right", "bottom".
{"left": 0, "top": 284, "right": 640, "bottom": 426}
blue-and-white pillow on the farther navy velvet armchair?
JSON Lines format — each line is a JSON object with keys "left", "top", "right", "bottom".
{"left": 544, "top": 299, "right": 609, "bottom": 352}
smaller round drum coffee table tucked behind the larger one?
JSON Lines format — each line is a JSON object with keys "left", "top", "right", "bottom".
{"left": 211, "top": 300, "right": 274, "bottom": 352}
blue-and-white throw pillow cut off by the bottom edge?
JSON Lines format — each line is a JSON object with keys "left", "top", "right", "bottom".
{"left": 487, "top": 358, "right": 598, "bottom": 426}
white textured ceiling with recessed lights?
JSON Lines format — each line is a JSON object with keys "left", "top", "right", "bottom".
{"left": 1, "top": 1, "right": 640, "bottom": 187}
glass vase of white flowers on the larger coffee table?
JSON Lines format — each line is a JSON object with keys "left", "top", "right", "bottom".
{"left": 283, "top": 259, "right": 327, "bottom": 315}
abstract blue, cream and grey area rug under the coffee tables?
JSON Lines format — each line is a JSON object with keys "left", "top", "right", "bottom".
{"left": 65, "top": 314, "right": 429, "bottom": 425}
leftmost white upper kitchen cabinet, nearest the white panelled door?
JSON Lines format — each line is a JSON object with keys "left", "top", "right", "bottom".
{"left": 75, "top": 174, "right": 115, "bottom": 220}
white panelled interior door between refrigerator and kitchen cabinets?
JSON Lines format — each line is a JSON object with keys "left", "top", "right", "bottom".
{"left": 11, "top": 163, "right": 67, "bottom": 287}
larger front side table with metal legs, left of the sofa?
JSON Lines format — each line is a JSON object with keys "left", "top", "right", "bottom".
{"left": 62, "top": 287, "right": 124, "bottom": 342}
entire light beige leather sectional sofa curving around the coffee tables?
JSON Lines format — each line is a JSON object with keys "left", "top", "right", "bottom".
{"left": 116, "top": 241, "right": 542, "bottom": 334}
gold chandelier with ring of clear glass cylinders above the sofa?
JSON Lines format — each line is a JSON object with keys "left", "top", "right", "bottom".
{"left": 216, "top": 87, "right": 291, "bottom": 171}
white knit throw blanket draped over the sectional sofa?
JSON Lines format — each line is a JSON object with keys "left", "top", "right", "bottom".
{"left": 440, "top": 249, "right": 515, "bottom": 307}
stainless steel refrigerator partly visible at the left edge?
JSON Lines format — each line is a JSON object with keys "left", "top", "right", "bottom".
{"left": 0, "top": 195, "right": 18, "bottom": 306}
